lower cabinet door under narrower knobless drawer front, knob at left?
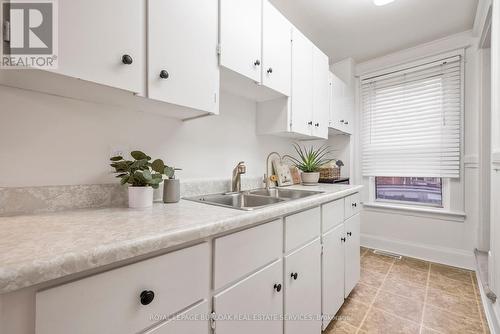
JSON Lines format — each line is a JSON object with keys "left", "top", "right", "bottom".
{"left": 285, "top": 239, "right": 321, "bottom": 334}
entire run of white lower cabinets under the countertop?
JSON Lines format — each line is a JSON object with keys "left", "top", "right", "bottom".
{"left": 31, "top": 194, "right": 360, "bottom": 334}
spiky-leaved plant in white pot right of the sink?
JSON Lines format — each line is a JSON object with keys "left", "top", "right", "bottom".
{"left": 290, "top": 144, "right": 333, "bottom": 185}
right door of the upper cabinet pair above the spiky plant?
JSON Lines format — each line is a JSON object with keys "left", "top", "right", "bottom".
{"left": 313, "top": 46, "right": 330, "bottom": 139}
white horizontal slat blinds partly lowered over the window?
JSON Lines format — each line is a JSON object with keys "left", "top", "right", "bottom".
{"left": 361, "top": 56, "right": 462, "bottom": 178}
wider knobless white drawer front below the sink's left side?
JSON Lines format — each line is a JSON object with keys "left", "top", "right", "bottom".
{"left": 214, "top": 220, "right": 283, "bottom": 289}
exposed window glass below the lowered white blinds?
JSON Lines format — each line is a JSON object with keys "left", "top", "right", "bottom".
{"left": 375, "top": 176, "right": 443, "bottom": 207}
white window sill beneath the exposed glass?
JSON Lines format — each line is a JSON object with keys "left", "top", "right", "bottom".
{"left": 363, "top": 202, "right": 466, "bottom": 222}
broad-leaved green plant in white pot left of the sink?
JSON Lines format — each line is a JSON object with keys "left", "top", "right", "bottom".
{"left": 110, "top": 151, "right": 170, "bottom": 208}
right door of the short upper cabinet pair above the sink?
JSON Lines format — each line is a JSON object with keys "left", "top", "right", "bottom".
{"left": 262, "top": 0, "right": 292, "bottom": 96}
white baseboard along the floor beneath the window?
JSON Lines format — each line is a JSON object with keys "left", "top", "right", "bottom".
{"left": 361, "top": 234, "right": 475, "bottom": 270}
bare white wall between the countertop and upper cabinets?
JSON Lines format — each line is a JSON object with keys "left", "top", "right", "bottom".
{"left": 0, "top": 87, "right": 300, "bottom": 187}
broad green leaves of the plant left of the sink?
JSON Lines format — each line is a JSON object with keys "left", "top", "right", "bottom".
{"left": 110, "top": 151, "right": 176, "bottom": 189}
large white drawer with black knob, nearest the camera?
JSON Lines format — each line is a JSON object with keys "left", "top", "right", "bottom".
{"left": 36, "top": 243, "right": 210, "bottom": 334}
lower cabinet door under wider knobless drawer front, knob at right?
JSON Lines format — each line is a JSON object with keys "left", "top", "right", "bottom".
{"left": 214, "top": 260, "right": 283, "bottom": 334}
